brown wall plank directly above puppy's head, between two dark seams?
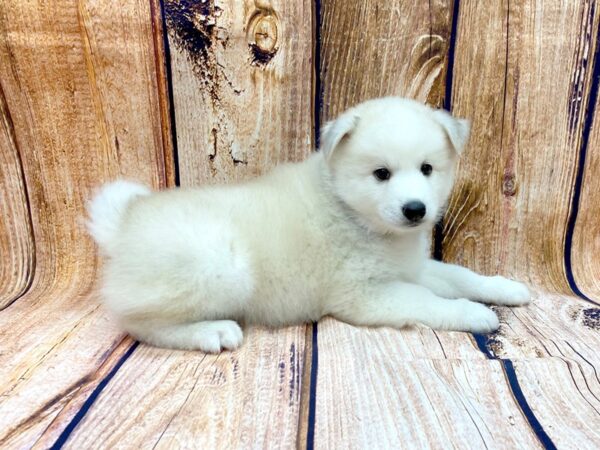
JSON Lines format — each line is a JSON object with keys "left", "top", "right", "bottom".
{"left": 321, "top": 0, "right": 452, "bottom": 118}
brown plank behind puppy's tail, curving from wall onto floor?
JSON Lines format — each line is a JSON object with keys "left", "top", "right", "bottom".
{"left": 0, "top": 0, "right": 169, "bottom": 448}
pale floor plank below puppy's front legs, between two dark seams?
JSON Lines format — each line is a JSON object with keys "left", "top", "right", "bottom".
{"left": 315, "top": 320, "right": 539, "bottom": 448}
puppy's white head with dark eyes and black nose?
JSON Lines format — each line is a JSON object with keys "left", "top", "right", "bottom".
{"left": 320, "top": 97, "right": 470, "bottom": 233}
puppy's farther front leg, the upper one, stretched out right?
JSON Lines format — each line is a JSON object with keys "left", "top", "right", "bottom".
{"left": 420, "top": 259, "right": 531, "bottom": 306}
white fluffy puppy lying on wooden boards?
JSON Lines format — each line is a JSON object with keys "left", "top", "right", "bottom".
{"left": 89, "top": 98, "right": 530, "bottom": 352}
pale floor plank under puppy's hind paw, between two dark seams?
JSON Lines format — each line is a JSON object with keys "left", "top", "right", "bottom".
{"left": 66, "top": 327, "right": 305, "bottom": 449}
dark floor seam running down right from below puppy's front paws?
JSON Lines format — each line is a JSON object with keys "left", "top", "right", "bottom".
{"left": 473, "top": 333, "right": 556, "bottom": 450}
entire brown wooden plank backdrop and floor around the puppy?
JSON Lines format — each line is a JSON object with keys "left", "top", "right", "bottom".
{"left": 0, "top": 0, "right": 600, "bottom": 450}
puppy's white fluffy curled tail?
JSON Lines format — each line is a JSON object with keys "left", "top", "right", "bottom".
{"left": 87, "top": 180, "right": 150, "bottom": 249}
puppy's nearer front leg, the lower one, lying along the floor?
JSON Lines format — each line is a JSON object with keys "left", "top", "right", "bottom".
{"left": 328, "top": 282, "right": 499, "bottom": 333}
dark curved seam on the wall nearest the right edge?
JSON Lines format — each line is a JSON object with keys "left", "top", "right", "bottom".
{"left": 564, "top": 5, "right": 600, "bottom": 305}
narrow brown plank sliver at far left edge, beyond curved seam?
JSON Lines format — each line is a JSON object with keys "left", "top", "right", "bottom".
{"left": 0, "top": 83, "right": 35, "bottom": 310}
